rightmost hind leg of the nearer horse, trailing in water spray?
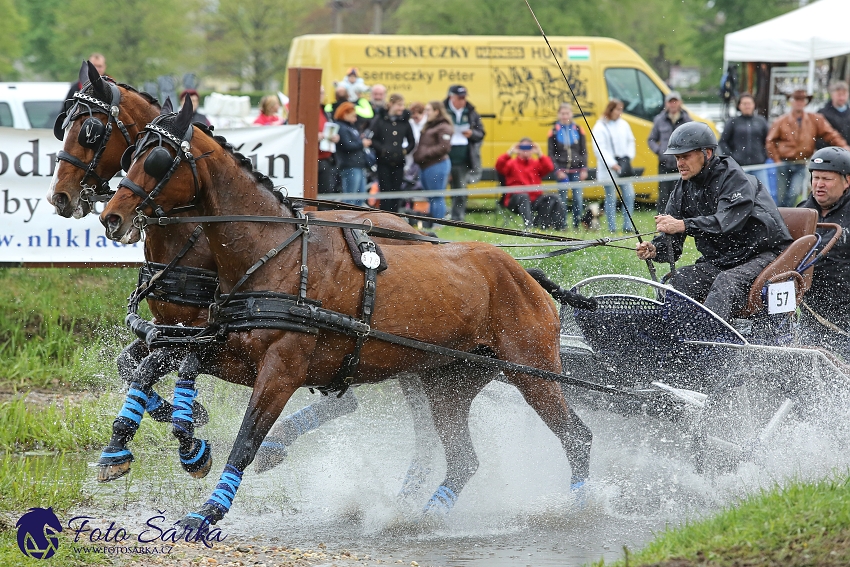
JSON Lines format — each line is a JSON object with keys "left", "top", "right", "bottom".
{"left": 509, "top": 374, "right": 593, "bottom": 491}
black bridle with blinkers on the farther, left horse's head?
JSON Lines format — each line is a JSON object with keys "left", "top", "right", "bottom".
{"left": 53, "top": 82, "right": 132, "bottom": 205}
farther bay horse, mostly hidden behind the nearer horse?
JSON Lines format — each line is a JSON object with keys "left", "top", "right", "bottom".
{"left": 47, "top": 61, "right": 444, "bottom": 492}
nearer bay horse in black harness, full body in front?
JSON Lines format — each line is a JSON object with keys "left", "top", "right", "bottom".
{"left": 100, "top": 100, "right": 592, "bottom": 530}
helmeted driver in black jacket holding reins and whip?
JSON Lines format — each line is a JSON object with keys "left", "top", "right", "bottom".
{"left": 637, "top": 122, "right": 791, "bottom": 321}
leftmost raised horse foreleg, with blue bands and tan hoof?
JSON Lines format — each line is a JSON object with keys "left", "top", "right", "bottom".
{"left": 97, "top": 348, "right": 182, "bottom": 482}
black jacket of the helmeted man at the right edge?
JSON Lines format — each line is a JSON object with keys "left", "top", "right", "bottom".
{"left": 800, "top": 191, "right": 850, "bottom": 327}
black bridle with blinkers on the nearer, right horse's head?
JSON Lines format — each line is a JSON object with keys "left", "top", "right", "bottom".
{"left": 118, "top": 113, "right": 210, "bottom": 222}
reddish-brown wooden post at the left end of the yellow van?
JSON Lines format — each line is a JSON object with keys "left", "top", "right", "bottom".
{"left": 289, "top": 67, "right": 322, "bottom": 199}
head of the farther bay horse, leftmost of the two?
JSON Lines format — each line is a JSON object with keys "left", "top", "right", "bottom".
{"left": 47, "top": 61, "right": 158, "bottom": 218}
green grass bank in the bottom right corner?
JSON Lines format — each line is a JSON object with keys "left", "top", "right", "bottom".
{"left": 594, "top": 478, "right": 850, "bottom": 567}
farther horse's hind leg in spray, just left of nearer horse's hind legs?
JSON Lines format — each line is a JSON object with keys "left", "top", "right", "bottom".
{"left": 398, "top": 374, "right": 434, "bottom": 499}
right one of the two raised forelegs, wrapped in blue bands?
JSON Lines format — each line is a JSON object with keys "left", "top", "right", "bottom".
{"left": 171, "top": 352, "right": 212, "bottom": 478}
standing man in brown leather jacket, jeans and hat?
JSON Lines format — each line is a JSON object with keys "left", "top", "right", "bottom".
{"left": 765, "top": 89, "right": 850, "bottom": 207}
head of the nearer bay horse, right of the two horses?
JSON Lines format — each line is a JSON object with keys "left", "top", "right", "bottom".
{"left": 100, "top": 96, "right": 202, "bottom": 244}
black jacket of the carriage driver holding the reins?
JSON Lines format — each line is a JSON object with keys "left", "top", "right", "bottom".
{"left": 652, "top": 156, "right": 792, "bottom": 270}
